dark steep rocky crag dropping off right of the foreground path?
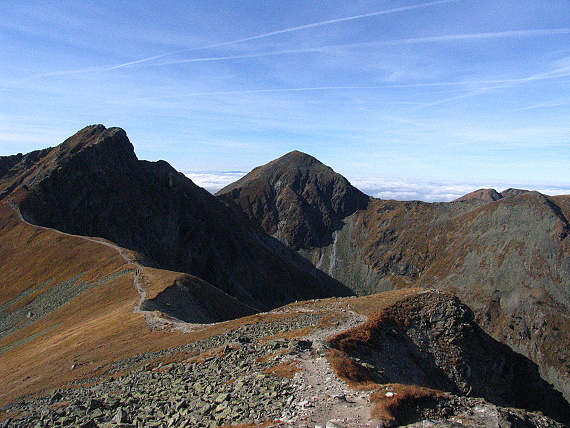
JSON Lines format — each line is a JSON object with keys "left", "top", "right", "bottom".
{"left": 330, "top": 291, "right": 570, "bottom": 423}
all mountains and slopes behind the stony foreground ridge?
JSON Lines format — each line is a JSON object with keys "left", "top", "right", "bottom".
{"left": 0, "top": 125, "right": 570, "bottom": 419}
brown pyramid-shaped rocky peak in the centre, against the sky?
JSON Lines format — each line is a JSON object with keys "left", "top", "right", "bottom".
{"left": 216, "top": 151, "right": 369, "bottom": 250}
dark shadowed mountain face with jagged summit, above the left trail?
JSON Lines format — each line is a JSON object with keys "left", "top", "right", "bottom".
{"left": 2, "top": 125, "right": 347, "bottom": 309}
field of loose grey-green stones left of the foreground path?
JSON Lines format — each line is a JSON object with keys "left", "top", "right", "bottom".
{"left": 0, "top": 314, "right": 319, "bottom": 428}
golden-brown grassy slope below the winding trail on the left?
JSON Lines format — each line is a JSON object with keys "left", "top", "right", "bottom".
{"left": 0, "top": 202, "right": 193, "bottom": 402}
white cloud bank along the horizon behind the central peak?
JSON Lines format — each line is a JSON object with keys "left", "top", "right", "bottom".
{"left": 185, "top": 171, "right": 570, "bottom": 202}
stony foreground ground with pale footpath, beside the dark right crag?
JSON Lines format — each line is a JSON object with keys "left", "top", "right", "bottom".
{"left": 0, "top": 298, "right": 563, "bottom": 428}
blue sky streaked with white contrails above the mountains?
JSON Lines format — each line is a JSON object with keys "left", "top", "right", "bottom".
{"left": 0, "top": 0, "right": 570, "bottom": 200}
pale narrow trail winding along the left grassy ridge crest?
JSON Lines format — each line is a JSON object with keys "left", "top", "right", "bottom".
{"left": 7, "top": 195, "right": 151, "bottom": 320}
